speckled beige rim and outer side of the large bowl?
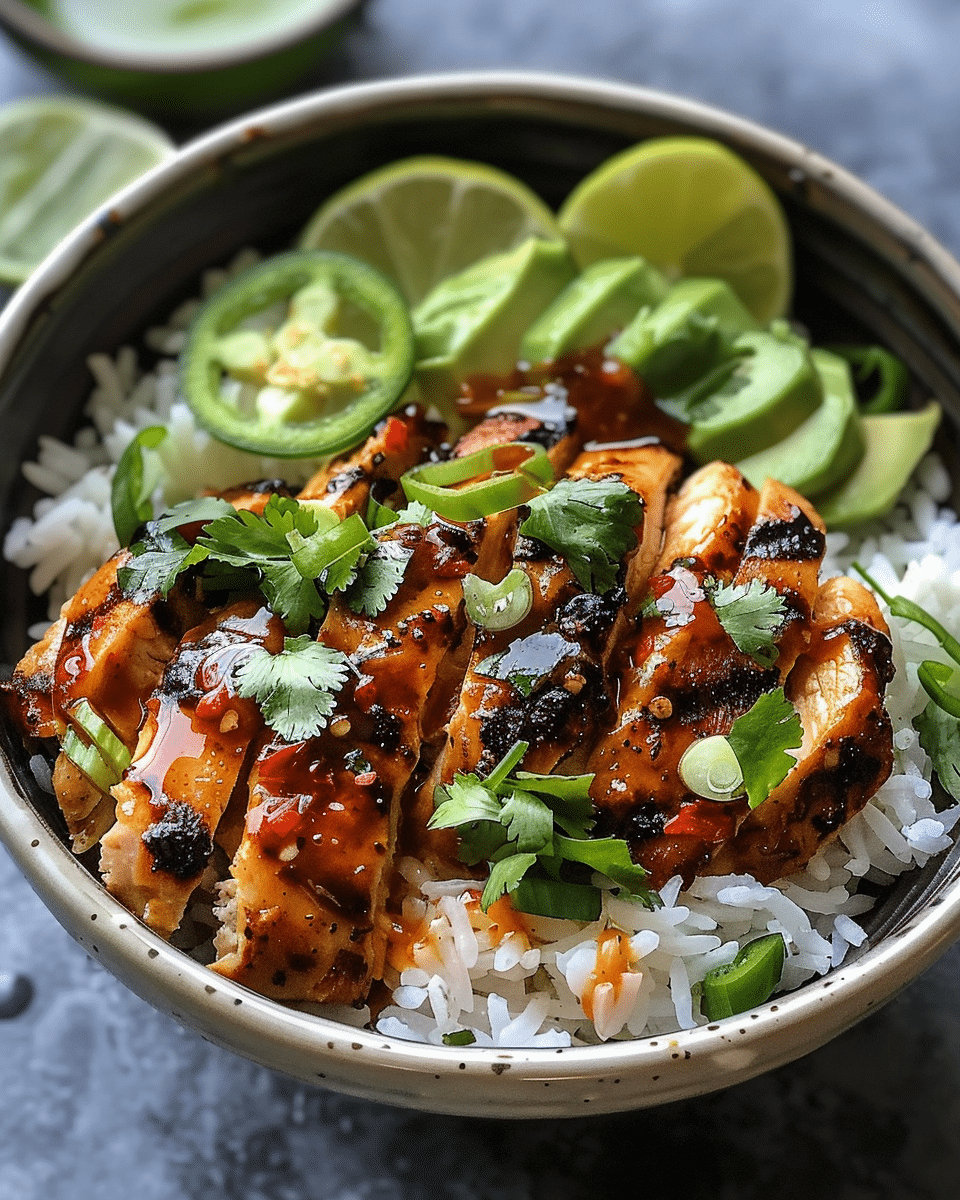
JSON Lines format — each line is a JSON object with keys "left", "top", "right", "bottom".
{"left": 0, "top": 72, "right": 960, "bottom": 1117}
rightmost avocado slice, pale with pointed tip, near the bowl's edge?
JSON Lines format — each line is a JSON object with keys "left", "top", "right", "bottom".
{"left": 817, "top": 400, "right": 941, "bottom": 529}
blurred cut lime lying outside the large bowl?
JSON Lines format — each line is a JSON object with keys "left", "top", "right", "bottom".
{"left": 0, "top": 96, "right": 174, "bottom": 283}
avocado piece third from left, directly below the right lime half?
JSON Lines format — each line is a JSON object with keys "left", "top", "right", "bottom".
{"left": 607, "top": 278, "right": 757, "bottom": 397}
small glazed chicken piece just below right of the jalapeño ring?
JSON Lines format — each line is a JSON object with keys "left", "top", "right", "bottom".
{"left": 296, "top": 404, "right": 446, "bottom": 517}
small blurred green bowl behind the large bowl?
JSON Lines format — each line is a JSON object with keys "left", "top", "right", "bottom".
{"left": 0, "top": 0, "right": 361, "bottom": 125}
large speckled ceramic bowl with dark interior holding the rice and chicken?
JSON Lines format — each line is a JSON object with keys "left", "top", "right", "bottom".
{"left": 0, "top": 73, "right": 960, "bottom": 1117}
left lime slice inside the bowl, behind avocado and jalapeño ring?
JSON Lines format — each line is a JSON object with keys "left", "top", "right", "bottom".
{"left": 300, "top": 156, "right": 560, "bottom": 305}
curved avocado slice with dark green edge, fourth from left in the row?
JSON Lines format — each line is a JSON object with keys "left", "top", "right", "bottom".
{"left": 686, "top": 323, "right": 823, "bottom": 462}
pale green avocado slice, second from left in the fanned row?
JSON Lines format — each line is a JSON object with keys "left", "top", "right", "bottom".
{"left": 520, "top": 256, "right": 668, "bottom": 364}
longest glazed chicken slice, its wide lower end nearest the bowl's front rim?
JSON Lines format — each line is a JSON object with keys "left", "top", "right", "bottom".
{"left": 214, "top": 522, "right": 502, "bottom": 1003}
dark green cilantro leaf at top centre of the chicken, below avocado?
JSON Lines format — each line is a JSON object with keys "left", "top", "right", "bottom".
{"left": 520, "top": 479, "right": 643, "bottom": 593}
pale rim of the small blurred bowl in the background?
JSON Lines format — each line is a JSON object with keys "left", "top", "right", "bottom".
{"left": 0, "top": 0, "right": 362, "bottom": 76}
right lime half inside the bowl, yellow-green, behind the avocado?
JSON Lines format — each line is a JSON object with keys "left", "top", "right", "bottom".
{"left": 558, "top": 138, "right": 793, "bottom": 324}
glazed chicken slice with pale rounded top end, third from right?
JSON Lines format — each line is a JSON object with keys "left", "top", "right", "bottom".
{"left": 588, "top": 463, "right": 779, "bottom": 887}
